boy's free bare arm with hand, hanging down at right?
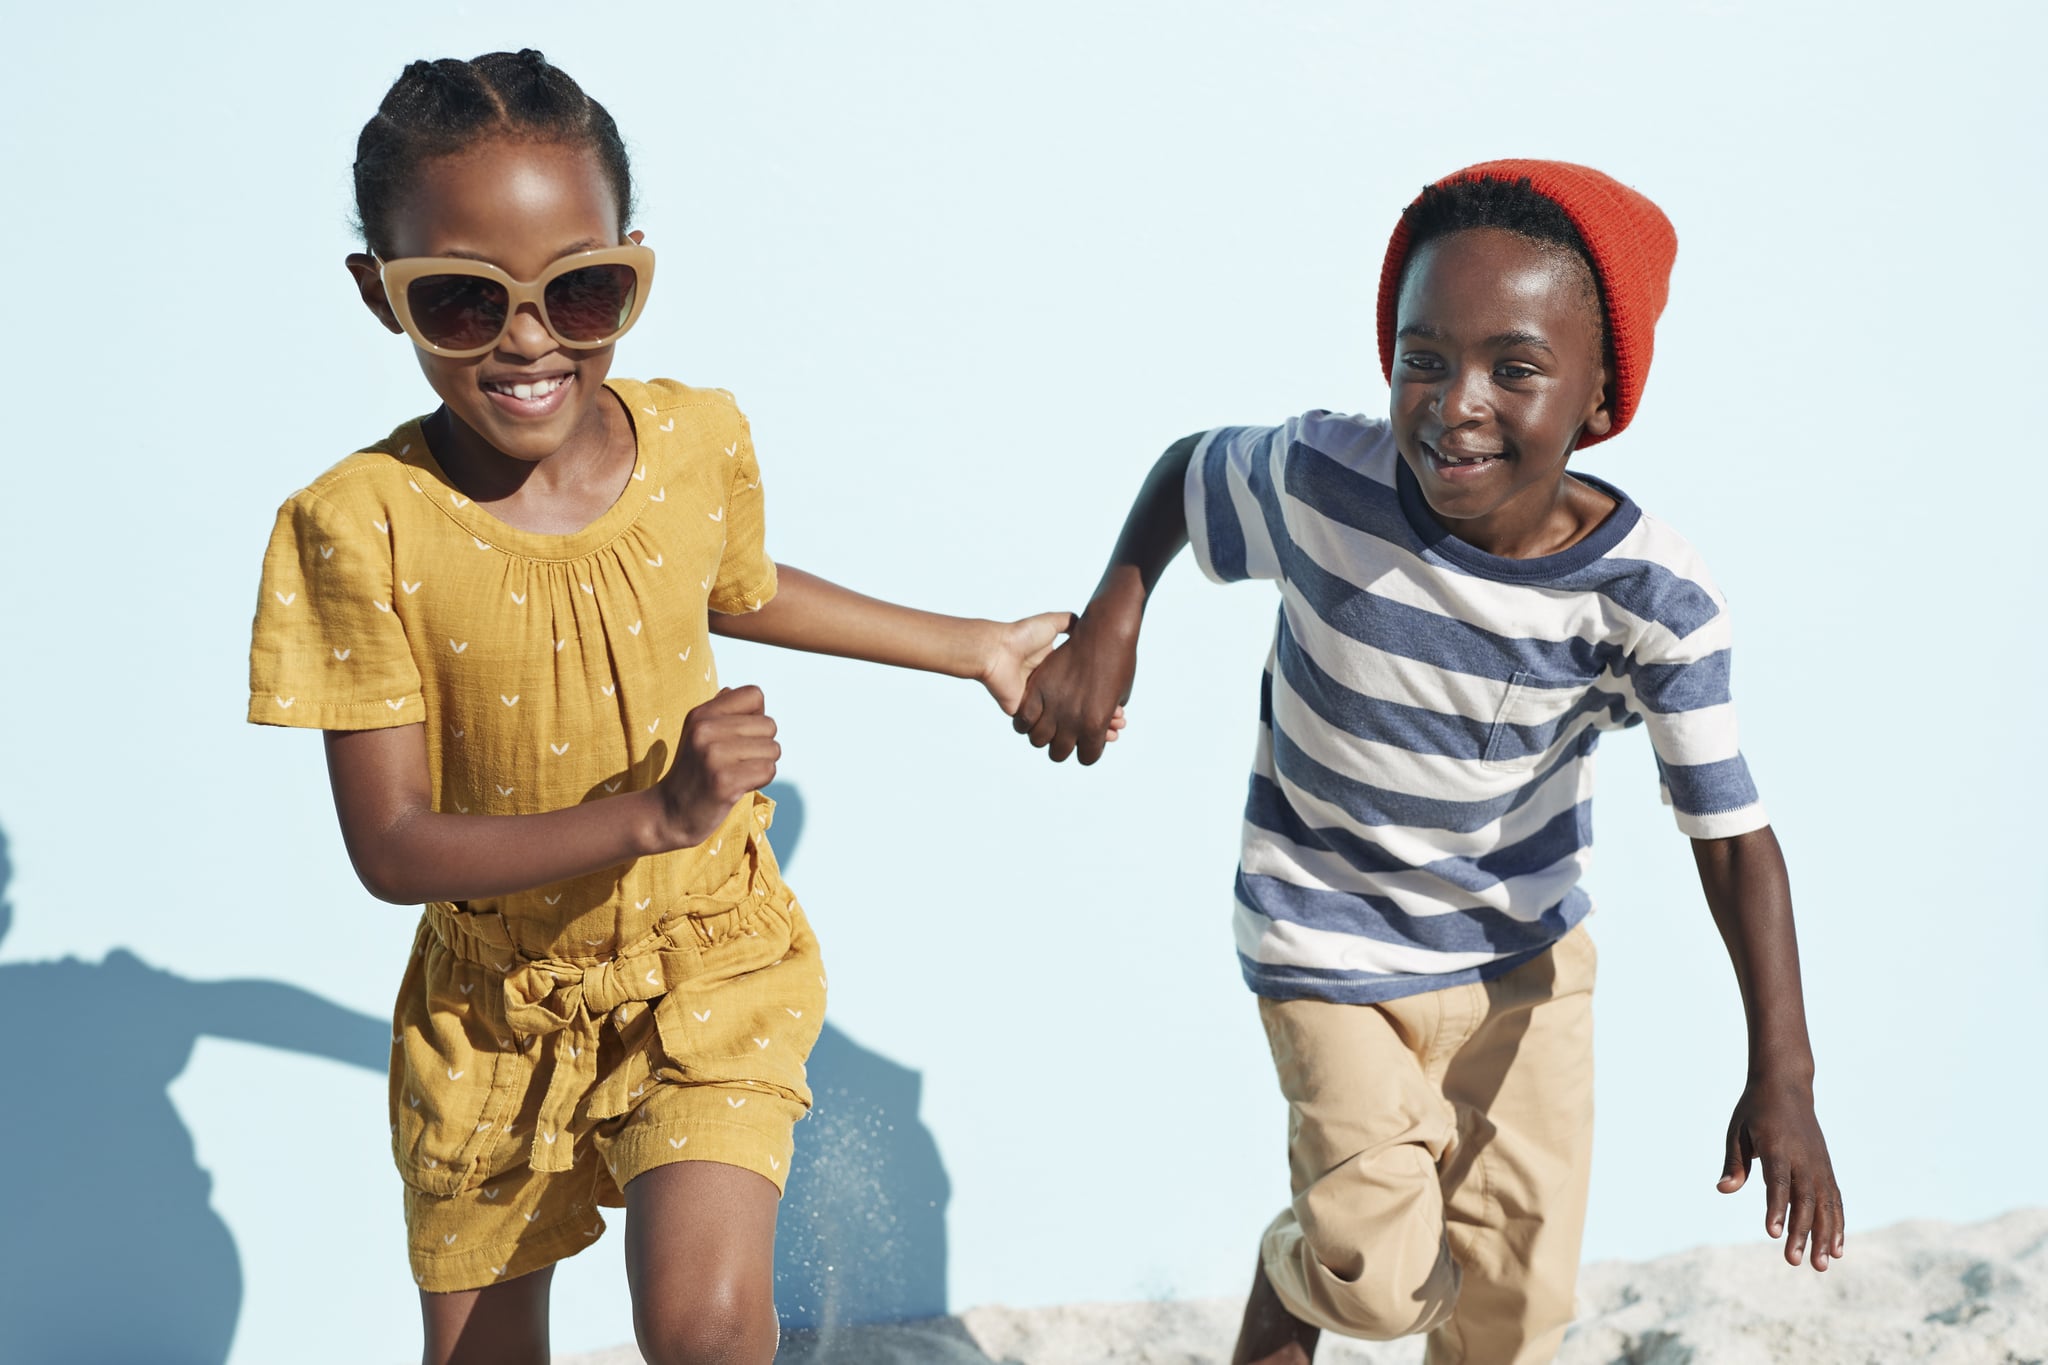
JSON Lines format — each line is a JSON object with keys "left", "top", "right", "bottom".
{"left": 1692, "top": 825, "right": 1845, "bottom": 1271}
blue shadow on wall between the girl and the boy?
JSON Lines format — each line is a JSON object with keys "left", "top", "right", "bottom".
{"left": 768, "top": 782, "right": 962, "bottom": 1359}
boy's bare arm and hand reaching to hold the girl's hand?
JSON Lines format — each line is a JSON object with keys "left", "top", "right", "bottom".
{"left": 1016, "top": 436, "right": 1200, "bottom": 763}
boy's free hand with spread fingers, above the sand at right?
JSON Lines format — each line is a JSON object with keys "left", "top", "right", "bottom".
{"left": 1718, "top": 1081, "right": 1847, "bottom": 1271}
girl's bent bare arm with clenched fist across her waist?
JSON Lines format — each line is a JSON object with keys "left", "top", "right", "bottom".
{"left": 326, "top": 688, "right": 782, "bottom": 905}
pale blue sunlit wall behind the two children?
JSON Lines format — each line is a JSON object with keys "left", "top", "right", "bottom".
{"left": 0, "top": 0, "right": 2048, "bottom": 1363}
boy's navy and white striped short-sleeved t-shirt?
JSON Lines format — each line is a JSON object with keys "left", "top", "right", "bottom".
{"left": 1186, "top": 411, "right": 1765, "bottom": 1003}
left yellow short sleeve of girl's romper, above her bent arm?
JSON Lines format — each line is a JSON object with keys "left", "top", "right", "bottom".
{"left": 248, "top": 491, "right": 426, "bottom": 731}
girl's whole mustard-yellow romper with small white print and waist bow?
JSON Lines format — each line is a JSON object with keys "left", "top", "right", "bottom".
{"left": 248, "top": 379, "right": 825, "bottom": 1291}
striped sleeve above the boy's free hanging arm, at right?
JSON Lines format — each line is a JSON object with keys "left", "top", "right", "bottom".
{"left": 1628, "top": 593, "right": 1769, "bottom": 839}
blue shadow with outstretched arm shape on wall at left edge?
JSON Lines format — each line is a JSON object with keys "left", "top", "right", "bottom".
{"left": 0, "top": 831, "right": 391, "bottom": 1365}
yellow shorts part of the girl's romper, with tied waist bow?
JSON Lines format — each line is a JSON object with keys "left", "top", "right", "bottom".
{"left": 391, "top": 882, "right": 825, "bottom": 1293}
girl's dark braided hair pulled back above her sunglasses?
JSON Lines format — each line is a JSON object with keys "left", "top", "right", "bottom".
{"left": 354, "top": 47, "right": 633, "bottom": 256}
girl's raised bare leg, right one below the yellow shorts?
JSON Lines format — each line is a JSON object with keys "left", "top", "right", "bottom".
{"left": 625, "top": 1160, "right": 778, "bottom": 1365}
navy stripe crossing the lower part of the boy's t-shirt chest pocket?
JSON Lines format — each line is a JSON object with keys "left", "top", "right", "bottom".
{"left": 1276, "top": 614, "right": 1632, "bottom": 761}
